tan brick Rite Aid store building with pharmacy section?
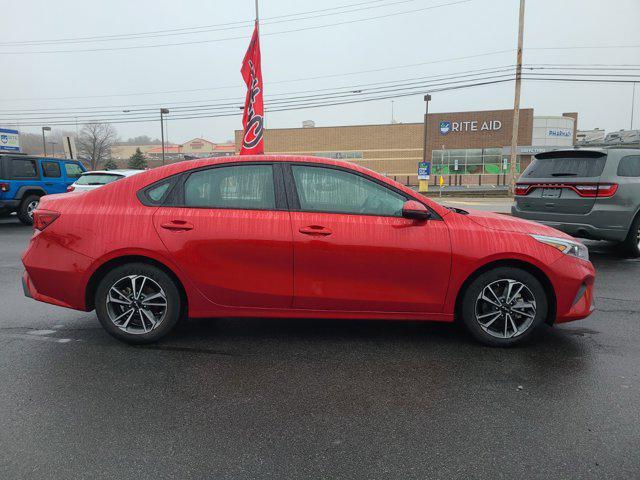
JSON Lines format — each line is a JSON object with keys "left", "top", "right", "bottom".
{"left": 235, "top": 108, "right": 577, "bottom": 185}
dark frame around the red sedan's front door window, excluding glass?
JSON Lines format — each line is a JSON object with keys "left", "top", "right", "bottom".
{"left": 283, "top": 162, "right": 442, "bottom": 220}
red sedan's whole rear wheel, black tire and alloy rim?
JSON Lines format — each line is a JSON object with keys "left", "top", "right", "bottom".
{"left": 95, "top": 263, "right": 182, "bottom": 344}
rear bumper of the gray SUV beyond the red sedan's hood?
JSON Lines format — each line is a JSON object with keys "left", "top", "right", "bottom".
{"left": 511, "top": 205, "right": 633, "bottom": 242}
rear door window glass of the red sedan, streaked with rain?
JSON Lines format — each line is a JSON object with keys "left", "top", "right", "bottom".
{"left": 184, "top": 165, "right": 276, "bottom": 210}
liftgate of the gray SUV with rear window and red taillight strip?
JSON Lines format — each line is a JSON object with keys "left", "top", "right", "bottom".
{"left": 515, "top": 150, "right": 616, "bottom": 214}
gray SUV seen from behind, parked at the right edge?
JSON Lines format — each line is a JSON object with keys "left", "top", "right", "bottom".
{"left": 512, "top": 148, "right": 640, "bottom": 257}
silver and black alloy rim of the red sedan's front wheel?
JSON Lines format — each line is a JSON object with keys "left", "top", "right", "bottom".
{"left": 475, "top": 279, "right": 536, "bottom": 338}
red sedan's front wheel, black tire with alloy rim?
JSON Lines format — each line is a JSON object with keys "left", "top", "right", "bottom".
{"left": 461, "top": 267, "right": 549, "bottom": 347}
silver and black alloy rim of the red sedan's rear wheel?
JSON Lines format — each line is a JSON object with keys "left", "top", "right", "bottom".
{"left": 106, "top": 275, "right": 167, "bottom": 335}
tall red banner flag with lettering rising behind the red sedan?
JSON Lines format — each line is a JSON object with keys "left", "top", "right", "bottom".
{"left": 240, "top": 22, "right": 264, "bottom": 155}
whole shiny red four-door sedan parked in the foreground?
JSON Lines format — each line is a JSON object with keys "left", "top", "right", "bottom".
{"left": 22, "top": 156, "right": 594, "bottom": 346}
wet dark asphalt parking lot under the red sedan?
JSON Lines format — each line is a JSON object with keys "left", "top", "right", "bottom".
{"left": 0, "top": 218, "right": 640, "bottom": 480}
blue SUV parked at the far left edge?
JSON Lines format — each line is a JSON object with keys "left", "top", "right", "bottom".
{"left": 0, "top": 154, "right": 86, "bottom": 225}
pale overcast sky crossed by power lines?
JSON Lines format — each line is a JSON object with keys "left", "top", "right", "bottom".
{"left": 0, "top": 0, "right": 640, "bottom": 143}
